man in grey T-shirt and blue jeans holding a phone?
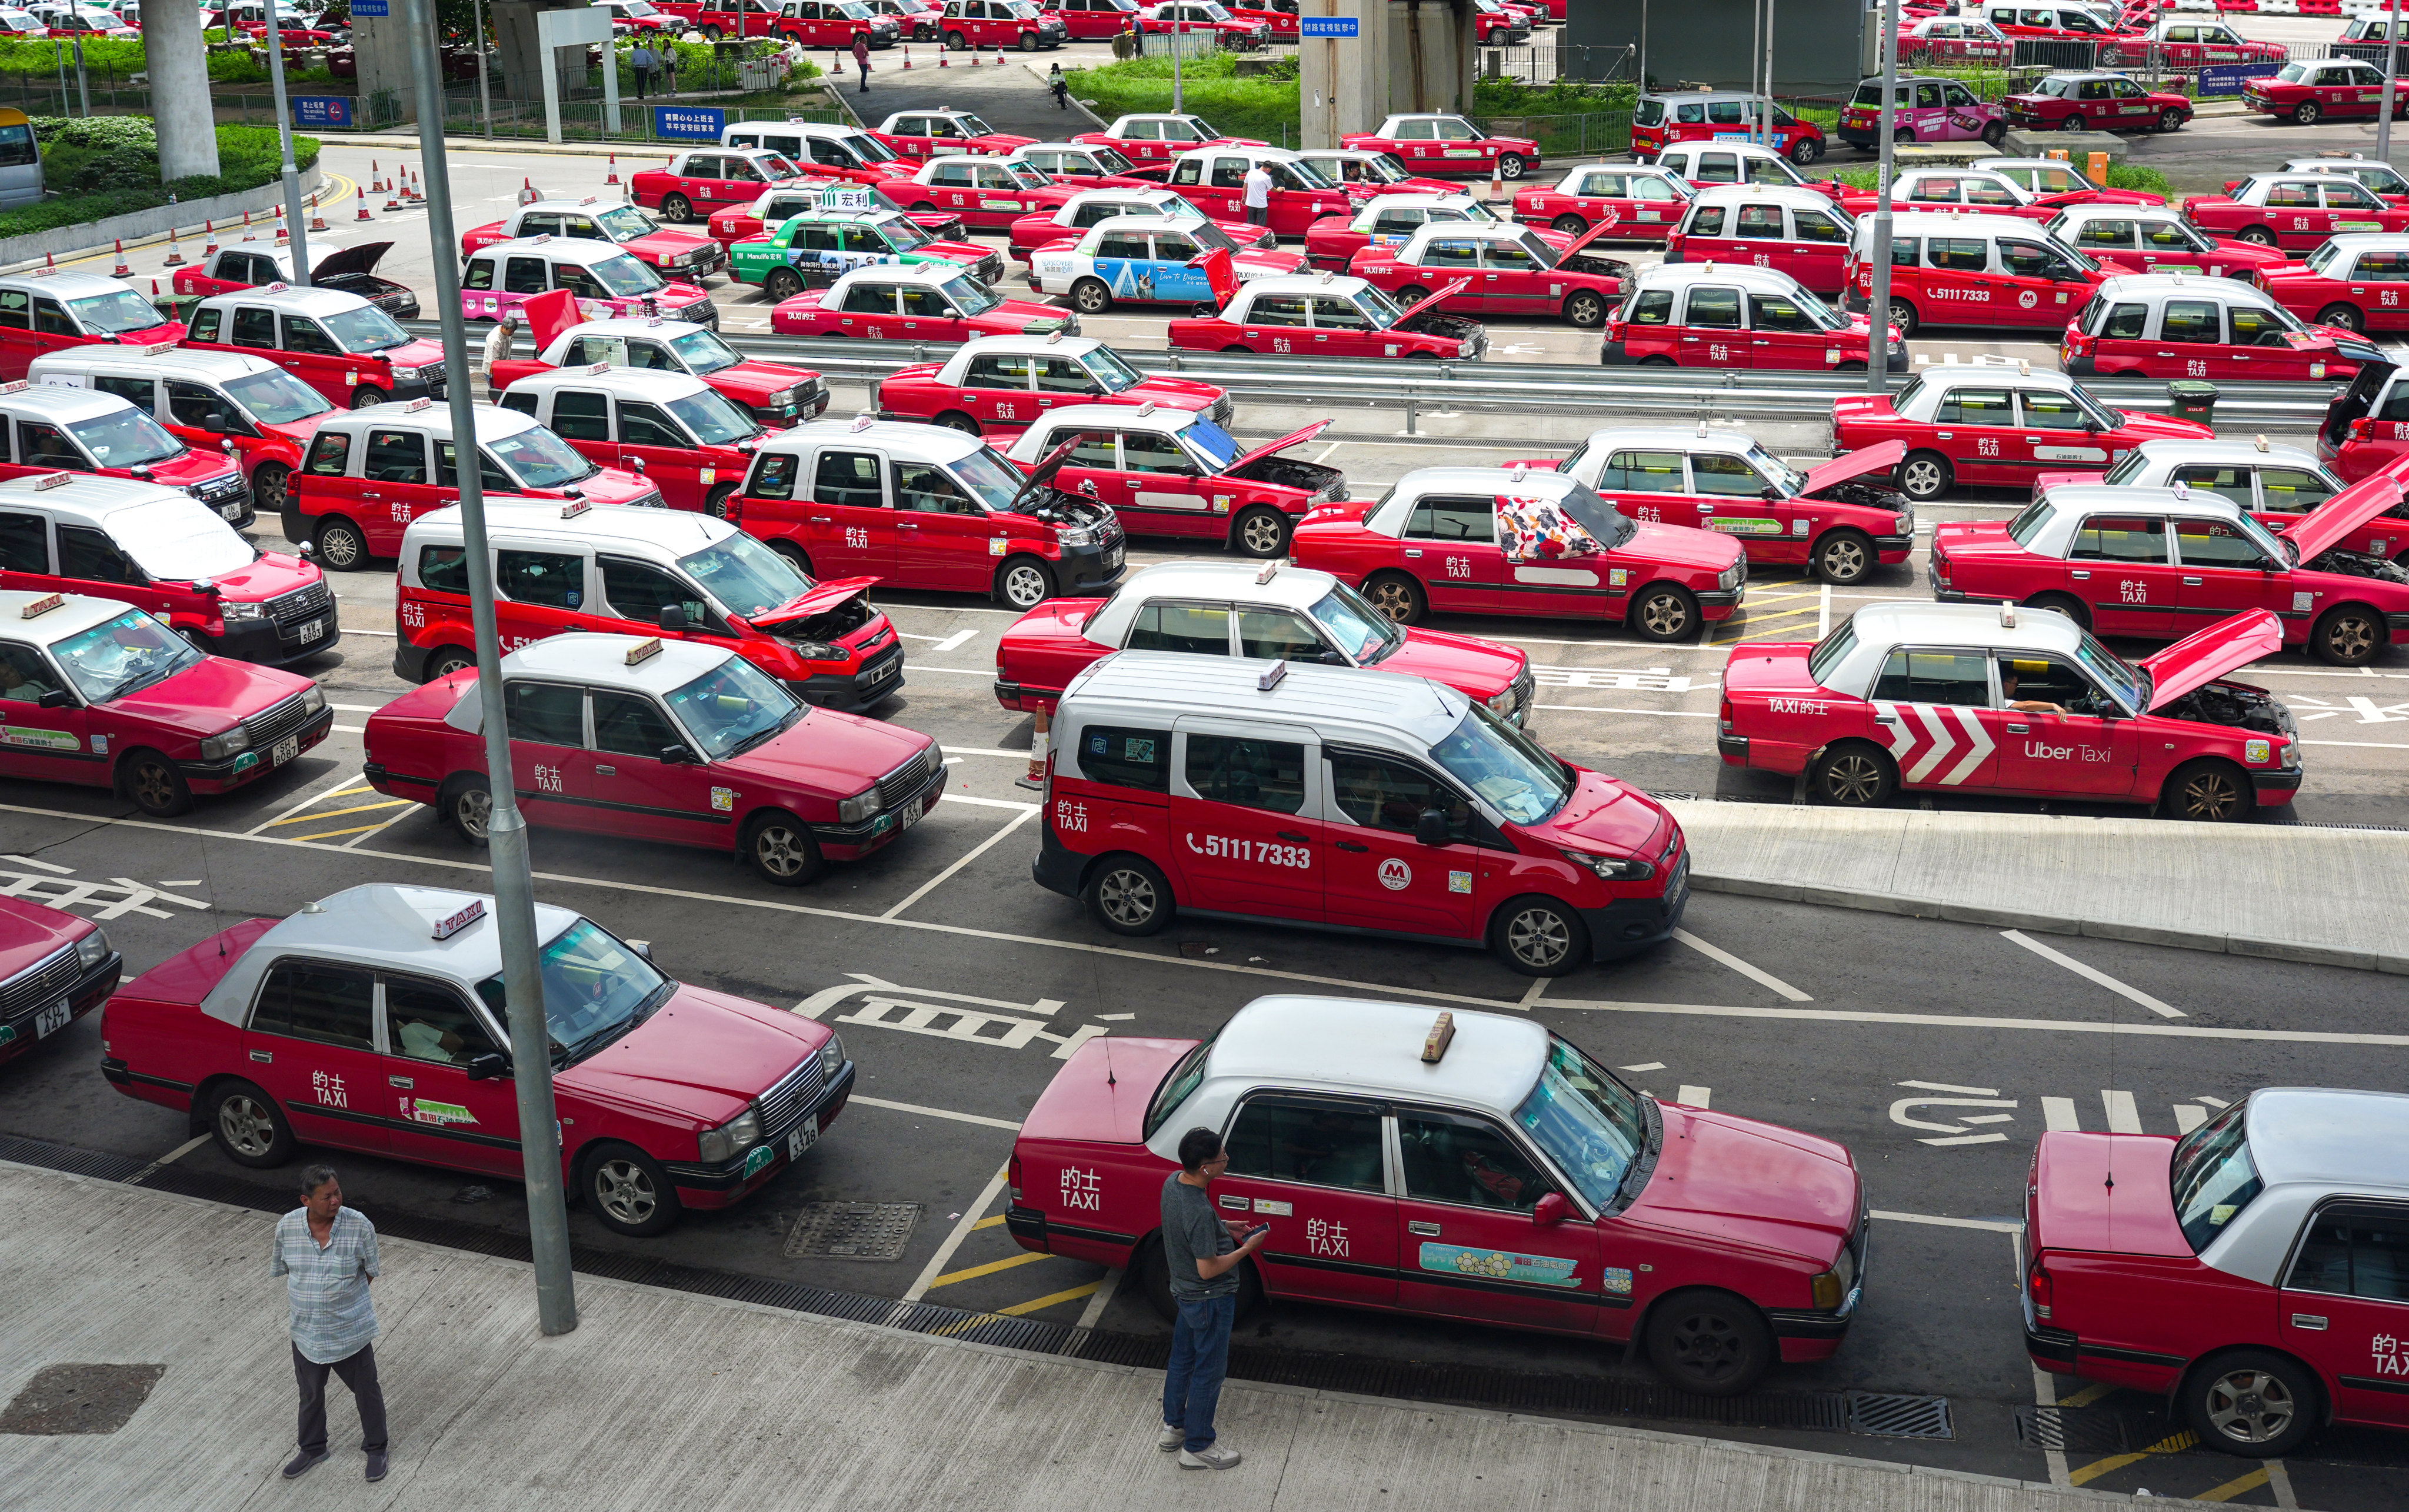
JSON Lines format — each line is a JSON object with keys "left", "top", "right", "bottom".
{"left": 1157, "top": 1129, "right": 1272, "bottom": 1471}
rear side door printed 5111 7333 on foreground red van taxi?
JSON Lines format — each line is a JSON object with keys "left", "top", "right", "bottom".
{"left": 1171, "top": 718, "right": 1327, "bottom": 924}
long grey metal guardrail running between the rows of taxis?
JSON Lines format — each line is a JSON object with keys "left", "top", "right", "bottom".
{"left": 424, "top": 320, "right": 2341, "bottom": 436}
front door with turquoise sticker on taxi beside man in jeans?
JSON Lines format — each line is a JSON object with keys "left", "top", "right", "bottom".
{"left": 1397, "top": 1107, "right": 1600, "bottom": 1334}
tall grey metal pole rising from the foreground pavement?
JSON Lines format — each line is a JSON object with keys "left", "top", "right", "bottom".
{"left": 402, "top": 0, "right": 578, "bottom": 1334}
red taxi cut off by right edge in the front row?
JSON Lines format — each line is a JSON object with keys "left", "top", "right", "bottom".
{"left": 2023, "top": 1093, "right": 2409, "bottom": 1461}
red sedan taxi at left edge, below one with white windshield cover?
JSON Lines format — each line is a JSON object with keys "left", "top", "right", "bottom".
{"left": 0, "top": 590, "right": 335, "bottom": 814}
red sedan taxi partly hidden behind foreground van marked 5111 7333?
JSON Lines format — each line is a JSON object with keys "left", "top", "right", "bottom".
{"left": 995, "top": 561, "right": 1537, "bottom": 725}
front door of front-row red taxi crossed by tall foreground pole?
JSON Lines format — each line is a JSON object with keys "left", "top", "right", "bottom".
{"left": 378, "top": 973, "right": 525, "bottom": 1175}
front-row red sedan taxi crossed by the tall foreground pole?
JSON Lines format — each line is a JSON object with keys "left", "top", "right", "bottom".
{"left": 101, "top": 881, "right": 853, "bottom": 1237}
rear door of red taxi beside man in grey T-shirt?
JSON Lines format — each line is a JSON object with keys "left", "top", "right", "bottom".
{"left": 1212, "top": 1091, "right": 1397, "bottom": 1307}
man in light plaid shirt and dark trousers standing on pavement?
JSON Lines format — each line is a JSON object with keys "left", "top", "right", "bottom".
{"left": 268, "top": 1165, "right": 388, "bottom": 1481}
